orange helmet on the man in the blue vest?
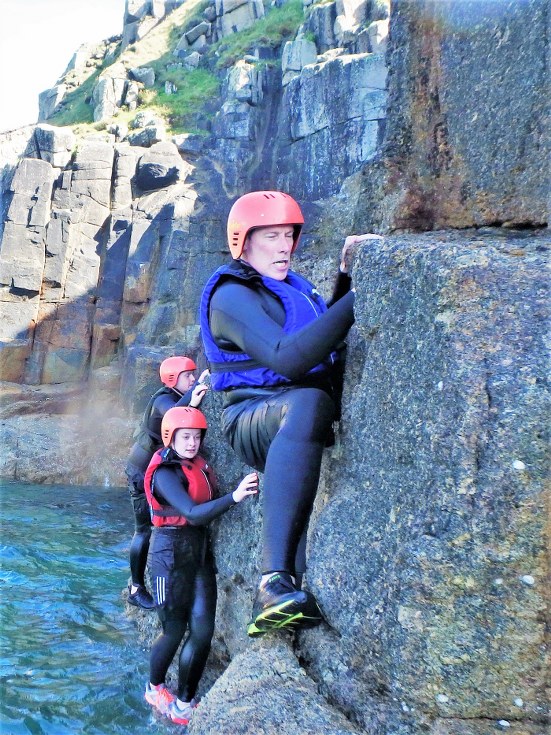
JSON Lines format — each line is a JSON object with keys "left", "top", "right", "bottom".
{"left": 228, "top": 191, "right": 304, "bottom": 260}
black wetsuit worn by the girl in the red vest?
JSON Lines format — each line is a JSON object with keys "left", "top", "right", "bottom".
{"left": 150, "top": 460, "right": 235, "bottom": 702}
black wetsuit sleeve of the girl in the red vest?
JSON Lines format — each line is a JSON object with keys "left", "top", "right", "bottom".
{"left": 155, "top": 467, "right": 235, "bottom": 526}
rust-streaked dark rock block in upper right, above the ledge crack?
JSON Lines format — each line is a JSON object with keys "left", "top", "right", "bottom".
{"left": 364, "top": 0, "right": 551, "bottom": 229}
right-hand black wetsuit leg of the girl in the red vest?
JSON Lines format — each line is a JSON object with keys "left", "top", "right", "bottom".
{"left": 178, "top": 566, "right": 216, "bottom": 702}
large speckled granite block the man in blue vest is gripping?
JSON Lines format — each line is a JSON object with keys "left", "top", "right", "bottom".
{"left": 309, "top": 233, "right": 549, "bottom": 731}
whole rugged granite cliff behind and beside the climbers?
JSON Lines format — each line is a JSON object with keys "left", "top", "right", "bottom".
{"left": 0, "top": 0, "right": 551, "bottom": 735}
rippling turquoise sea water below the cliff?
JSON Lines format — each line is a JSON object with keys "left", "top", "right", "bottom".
{"left": 0, "top": 483, "right": 175, "bottom": 735}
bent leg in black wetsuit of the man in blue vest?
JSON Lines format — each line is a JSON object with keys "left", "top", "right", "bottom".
{"left": 222, "top": 388, "right": 335, "bottom": 575}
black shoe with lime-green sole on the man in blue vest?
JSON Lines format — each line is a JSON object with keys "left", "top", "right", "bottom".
{"left": 247, "top": 572, "right": 322, "bottom": 638}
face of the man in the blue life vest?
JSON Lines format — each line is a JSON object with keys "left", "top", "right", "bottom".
{"left": 241, "top": 225, "right": 294, "bottom": 281}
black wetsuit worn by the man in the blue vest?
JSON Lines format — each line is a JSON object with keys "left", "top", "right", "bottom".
{"left": 204, "top": 261, "right": 354, "bottom": 575}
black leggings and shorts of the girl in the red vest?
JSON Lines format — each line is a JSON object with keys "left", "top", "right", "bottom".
{"left": 150, "top": 528, "right": 217, "bottom": 702}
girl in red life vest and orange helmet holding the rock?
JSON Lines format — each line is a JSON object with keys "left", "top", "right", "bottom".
{"left": 144, "top": 407, "right": 258, "bottom": 725}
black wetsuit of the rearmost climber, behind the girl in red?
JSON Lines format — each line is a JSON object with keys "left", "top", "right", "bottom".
{"left": 125, "top": 386, "right": 195, "bottom": 587}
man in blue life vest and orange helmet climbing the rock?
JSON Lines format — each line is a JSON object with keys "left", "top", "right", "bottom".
{"left": 200, "top": 191, "right": 379, "bottom": 636}
